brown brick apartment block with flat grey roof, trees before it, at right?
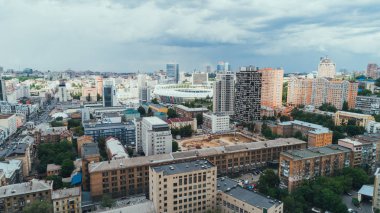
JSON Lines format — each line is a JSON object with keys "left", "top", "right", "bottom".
{"left": 278, "top": 144, "right": 351, "bottom": 191}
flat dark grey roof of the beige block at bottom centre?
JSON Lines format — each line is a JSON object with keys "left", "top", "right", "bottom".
{"left": 152, "top": 160, "right": 215, "bottom": 176}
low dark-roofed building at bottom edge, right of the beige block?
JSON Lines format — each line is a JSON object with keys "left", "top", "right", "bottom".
{"left": 216, "top": 177, "right": 284, "bottom": 213}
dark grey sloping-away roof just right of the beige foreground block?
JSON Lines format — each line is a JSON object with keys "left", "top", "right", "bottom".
{"left": 217, "top": 177, "right": 281, "bottom": 209}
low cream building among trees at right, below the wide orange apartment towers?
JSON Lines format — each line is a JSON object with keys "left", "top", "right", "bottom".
{"left": 334, "top": 111, "right": 375, "bottom": 127}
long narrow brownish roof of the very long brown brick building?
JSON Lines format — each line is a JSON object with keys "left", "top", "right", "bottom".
{"left": 89, "top": 138, "right": 306, "bottom": 173}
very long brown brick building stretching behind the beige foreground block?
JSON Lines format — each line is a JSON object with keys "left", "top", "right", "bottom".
{"left": 88, "top": 138, "right": 306, "bottom": 199}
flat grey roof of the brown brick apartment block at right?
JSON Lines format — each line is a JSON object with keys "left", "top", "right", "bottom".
{"left": 281, "top": 144, "right": 350, "bottom": 160}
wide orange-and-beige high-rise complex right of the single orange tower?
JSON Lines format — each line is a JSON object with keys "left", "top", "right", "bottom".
{"left": 287, "top": 77, "right": 358, "bottom": 109}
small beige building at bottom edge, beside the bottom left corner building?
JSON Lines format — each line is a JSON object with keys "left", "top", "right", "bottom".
{"left": 51, "top": 187, "right": 82, "bottom": 213}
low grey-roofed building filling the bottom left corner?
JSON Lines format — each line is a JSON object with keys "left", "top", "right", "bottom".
{"left": 0, "top": 179, "right": 53, "bottom": 212}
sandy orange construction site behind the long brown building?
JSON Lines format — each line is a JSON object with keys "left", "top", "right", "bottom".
{"left": 178, "top": 133, "right": 259, "bottom": 151}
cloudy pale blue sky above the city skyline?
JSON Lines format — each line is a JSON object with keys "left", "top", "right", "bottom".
{"left": 0, "top": 0, "right": 380, "bottom": 72}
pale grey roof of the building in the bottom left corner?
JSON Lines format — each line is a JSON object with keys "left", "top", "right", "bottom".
{"left": 0, "top": 179, "right": 53, "bottom": 198}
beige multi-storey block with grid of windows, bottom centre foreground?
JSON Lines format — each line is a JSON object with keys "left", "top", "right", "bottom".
{"left": 149, "top": 160, "right": 217, "bottom": 213}
